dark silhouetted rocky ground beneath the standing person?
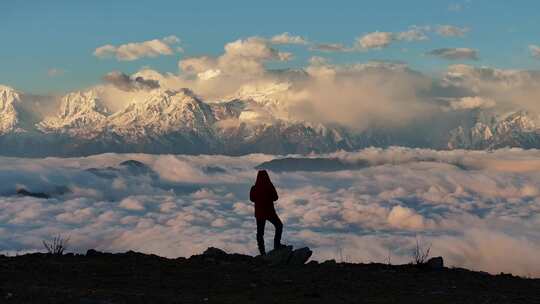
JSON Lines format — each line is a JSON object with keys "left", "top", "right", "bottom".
{"left": 0, "top": 248, "right": 540, "bottom": 304}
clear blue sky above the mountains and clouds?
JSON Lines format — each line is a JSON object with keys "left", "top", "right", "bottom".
{"left": 0, "top": 0, "right": 540, "bottom": 93}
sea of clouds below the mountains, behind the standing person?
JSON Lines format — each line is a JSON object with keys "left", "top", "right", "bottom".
{"left": 0, "top": 147, "right": 540, "bottom": 277}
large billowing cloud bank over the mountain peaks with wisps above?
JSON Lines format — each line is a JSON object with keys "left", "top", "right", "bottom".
{"left": 84, "top": 34, "right": 540, "bottom": 132}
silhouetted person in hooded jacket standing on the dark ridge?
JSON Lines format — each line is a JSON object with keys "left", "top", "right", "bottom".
{"left": 249, "top": 170, "right": 283, "bottom": 255}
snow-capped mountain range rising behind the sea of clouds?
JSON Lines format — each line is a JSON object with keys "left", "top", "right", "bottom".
{"left": 0, "top": 84, "right": 540, "bottom": 157}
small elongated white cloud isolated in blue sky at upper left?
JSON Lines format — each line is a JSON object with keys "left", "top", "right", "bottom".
{"left": 94, "top": 36, "right": 180, "bottom": 61}
